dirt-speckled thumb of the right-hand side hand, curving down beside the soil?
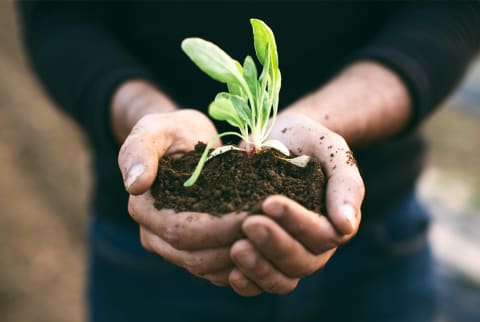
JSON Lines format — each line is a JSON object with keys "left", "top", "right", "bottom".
{"left": 271, "top": 113, "right": 364, "bottom": 235}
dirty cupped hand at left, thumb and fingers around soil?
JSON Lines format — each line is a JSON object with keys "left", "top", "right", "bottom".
{"left": 118, "top": 109, "right": 248, "bottom": 285}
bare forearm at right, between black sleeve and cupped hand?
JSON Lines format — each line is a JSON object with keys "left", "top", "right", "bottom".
{"left": 284, "top": 61, "right": 412, "bottom": 147}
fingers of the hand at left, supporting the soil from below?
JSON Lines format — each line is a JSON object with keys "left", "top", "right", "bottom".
{"left": 128, "top": 192, "right": 246, "bottom": 286}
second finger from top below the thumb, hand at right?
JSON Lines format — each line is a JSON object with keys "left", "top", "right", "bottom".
{"left": 242, "top": 216, "right": 333, "bottom": 277}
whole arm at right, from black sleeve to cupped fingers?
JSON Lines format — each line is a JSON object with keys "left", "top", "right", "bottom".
{"left": 229, "top": 2, "right": 480, "bottom": 296}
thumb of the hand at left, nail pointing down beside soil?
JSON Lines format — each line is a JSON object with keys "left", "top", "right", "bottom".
{"left": 118, "top": 119, "right": 172, "bottom": 195}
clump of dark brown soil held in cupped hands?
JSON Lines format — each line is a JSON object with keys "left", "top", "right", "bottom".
{"left": 151, "top": 143, "right": 325, "bottom": 215}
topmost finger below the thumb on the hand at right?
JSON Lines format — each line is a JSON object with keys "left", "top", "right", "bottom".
{"left": 262, "top": 195, "right": 342, "bottom": 255}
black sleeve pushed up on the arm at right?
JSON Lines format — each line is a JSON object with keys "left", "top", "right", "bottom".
{"left": 353, "top": 1, "right": 480, "bottom": 128}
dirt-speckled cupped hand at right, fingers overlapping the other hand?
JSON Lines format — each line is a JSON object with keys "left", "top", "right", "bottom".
{"left": 229, "top": 112, "right": 364, "bottom": 296}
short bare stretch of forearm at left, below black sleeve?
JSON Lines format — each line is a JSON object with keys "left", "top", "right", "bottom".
{"left": 110, "top": 80, "right": 177, "bottom": 143}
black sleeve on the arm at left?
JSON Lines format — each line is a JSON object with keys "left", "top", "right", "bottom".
{"left": 17, "top": 1, "right": 152, "bottom": 149}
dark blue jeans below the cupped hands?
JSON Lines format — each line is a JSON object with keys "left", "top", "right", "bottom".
{"left": 88, "top": 194, "right": 434, "bottom": 322}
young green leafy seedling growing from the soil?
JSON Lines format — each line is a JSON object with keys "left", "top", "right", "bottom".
{"left": 182, "top": 19, "right": 304, "bottom": 187}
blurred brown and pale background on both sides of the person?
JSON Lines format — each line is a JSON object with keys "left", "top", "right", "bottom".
{"left": 0, "top": 0, "right": 480, "bottom": 322}
